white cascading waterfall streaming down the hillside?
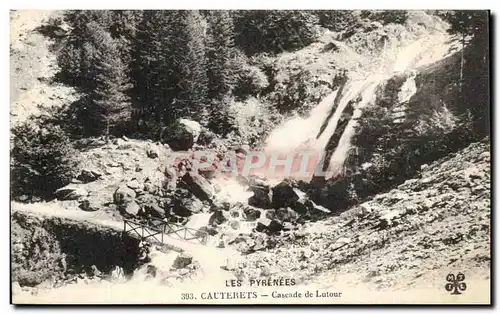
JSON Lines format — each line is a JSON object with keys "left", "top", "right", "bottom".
{"left": 265, "top": 30, "right": 451, "bottom": 179}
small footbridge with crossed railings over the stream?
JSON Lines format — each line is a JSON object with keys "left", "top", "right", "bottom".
{"left": 123, "top": 217, "right": 208, "bottom": 245}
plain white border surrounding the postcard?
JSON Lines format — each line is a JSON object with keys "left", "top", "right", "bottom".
{"left": 0, "top": 0, "right": 500, "bottom": 313}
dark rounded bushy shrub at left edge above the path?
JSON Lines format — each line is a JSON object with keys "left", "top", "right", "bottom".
{"left": 11, "top": 122, "right": 77, "bottom": 199}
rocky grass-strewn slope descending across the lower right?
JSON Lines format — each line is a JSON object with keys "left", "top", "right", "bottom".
{"left": 239, "top": 139, "right": 491, "bottom": 288}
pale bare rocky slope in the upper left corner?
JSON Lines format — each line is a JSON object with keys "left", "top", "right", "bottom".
{"left": 10, "top": 10, "right": 78, "bottom": 126}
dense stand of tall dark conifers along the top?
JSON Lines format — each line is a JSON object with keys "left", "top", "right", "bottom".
{"left": 54, "top": 10, "right": 338, "bottom": 136}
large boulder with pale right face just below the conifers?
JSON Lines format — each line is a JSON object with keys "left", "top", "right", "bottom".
{"left": 160, "top": 119, "right": 201, "bottom": 151}
